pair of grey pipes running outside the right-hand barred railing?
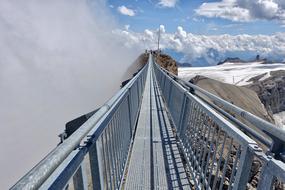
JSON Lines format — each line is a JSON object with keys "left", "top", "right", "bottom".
{"left": 155, "top": 64, "right": 285, "bottom": 162}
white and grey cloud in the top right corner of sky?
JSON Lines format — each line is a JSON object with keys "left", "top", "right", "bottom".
{"left": 196, "top": 0, "right": 285, "bottom": 24}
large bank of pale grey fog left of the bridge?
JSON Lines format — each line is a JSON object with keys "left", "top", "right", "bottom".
{"left": 0, "top": 0, "right": 138, "bottom": 189}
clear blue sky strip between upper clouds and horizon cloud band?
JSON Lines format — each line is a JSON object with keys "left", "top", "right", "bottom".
{"left": 108, "top": 0, "right": 285, "bottom": 35}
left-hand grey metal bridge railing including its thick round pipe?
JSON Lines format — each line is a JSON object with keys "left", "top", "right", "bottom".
{"left": 11, "top": 61, "right": 148, "bottom": 189}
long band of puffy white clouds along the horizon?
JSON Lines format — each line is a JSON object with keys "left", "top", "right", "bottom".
{"left": 115, "top": 26, "right": 285, "bottom": 64}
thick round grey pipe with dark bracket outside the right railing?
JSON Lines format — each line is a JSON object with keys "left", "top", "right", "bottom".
{"left": 155, "top": 63, "right": 285, "bottom": 159}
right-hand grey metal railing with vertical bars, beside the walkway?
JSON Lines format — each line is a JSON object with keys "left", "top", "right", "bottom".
{"left": 154, "top": 60, "right": 285, "bottom": 189}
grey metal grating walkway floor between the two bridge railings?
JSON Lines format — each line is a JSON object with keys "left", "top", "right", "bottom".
{"left": 124, "top": 59, "right": 190, "bottom": 190}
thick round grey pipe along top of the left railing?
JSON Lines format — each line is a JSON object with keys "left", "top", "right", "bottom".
{"left": 11, "top": 59, "right": 147, "bottom": 189}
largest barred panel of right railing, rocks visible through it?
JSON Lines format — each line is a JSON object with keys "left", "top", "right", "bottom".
{"left": 179, "top": 96, "right": 250, "bottom": 189}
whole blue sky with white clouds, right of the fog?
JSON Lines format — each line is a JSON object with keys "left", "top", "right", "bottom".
{"left": 107, "top": 0, "right": 285, "bottom": 66}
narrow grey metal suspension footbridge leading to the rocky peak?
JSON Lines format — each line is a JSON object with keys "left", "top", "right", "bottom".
{"left": 11, "top": 53, "right": 285, "bottom": 190}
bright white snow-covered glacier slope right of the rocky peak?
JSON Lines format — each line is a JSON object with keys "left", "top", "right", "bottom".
{"left": 178, "top": 62, "right": 285, "bottom": 86}
